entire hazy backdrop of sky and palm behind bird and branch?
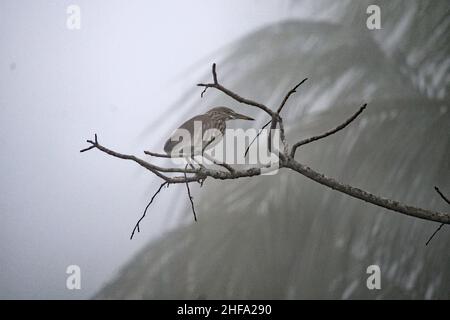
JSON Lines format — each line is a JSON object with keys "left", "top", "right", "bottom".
{"left": 0, "top": 0, "right": 450, "bottom": 299}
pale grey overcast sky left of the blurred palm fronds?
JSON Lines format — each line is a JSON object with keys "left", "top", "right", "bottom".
{"left": 0, "top": 0, "right": 304, "bottom": 298}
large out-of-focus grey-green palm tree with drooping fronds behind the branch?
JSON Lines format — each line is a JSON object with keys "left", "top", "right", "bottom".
{"left": 96, "top": 1, "right": 450, "bottom": 299}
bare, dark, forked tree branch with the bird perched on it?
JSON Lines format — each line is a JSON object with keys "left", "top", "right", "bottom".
{"left": 80, "top": 64, "right": 450, "bottom": 238}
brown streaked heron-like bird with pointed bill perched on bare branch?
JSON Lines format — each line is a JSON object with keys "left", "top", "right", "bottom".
{"left": 164, "top": 106, "right": 254, "bottom": 158}
